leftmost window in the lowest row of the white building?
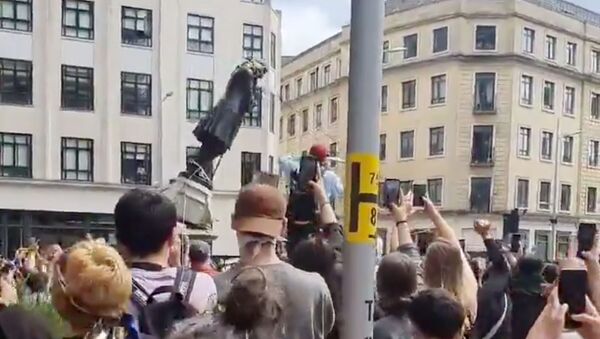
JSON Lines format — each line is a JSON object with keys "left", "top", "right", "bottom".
{"left": 0, "top": 133, "right": 32, "bottom": 178}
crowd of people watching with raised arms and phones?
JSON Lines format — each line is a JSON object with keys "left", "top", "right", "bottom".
{"left": 0, "top": 159, "right": 600, "bottom": 339}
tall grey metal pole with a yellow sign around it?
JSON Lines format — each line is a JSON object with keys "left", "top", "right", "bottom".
{"left": 342, "top": 0, "right": 384, "bottom": 339}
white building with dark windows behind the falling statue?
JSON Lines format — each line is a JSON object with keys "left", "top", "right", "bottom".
{"left": 0, "top": 0, "right": 281, "bottom": 255}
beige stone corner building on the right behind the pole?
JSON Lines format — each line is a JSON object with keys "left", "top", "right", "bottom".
{"left": 280, "top": 0, "right": 600, "bottom": 257}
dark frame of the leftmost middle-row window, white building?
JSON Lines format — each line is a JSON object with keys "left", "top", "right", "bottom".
{"left": 0, "top": 58, "right": 33, "bottom": 106}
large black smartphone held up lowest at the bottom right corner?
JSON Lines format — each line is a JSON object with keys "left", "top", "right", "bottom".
{"left": 558, "top": 270, "right": 588, "bottom": 329}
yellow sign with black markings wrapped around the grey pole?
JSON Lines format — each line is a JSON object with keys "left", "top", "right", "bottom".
{"left": 344, "top": 153, "right": 379, "bottom": 244}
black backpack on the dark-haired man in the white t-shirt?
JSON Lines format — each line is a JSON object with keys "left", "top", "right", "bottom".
{"left": 131, "top": 267, "right": 198, "bottom": 338}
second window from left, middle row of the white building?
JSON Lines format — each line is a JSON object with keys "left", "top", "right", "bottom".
{"left": 61, "top": 65, "right": 94, "bottom": 111}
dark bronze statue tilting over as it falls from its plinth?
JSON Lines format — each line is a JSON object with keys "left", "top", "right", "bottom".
{"left": 180, "top": 59, "right": 267, "bottom": 190}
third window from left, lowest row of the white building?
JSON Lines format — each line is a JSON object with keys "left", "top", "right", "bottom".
{"left": 121, "top": 142, "right": 152, "bottom": 185}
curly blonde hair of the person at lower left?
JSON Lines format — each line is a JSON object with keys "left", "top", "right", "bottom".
{"left": 51, "top": 240, "right": 131, "bottom": 330}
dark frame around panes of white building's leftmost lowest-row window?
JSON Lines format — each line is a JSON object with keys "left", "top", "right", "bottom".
{"left": 0, "top": 132, "right": 33, "bottom": 178}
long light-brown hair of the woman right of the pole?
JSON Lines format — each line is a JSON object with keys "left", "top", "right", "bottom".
{"left": 423, "top": 238, "right": 467, "bottom": 305}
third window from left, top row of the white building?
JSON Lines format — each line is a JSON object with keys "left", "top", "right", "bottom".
{"left": 121, "top": 6, "right": 152, "bottom": 47}
